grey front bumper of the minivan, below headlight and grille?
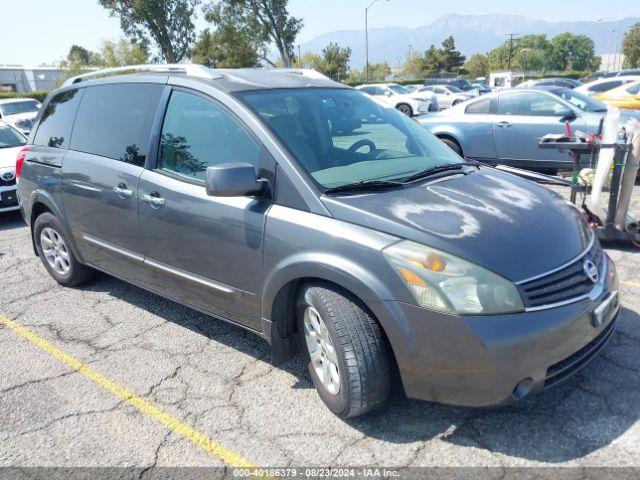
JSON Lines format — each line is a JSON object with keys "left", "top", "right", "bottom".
{"left": 387, "top": 255, "right": 620, "bottom": 407}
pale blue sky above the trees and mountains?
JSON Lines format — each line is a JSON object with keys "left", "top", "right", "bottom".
{"left": 0, "top": 0, "right": 640, "bottom": 64}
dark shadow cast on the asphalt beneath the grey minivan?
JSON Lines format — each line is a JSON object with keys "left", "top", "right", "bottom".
{"left": 82, "top": 275, "right": 640, "bottom": 464}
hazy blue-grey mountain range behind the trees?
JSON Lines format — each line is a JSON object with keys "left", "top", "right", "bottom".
{"left": 301, "top": 13, "right": 639, "bottom": 68}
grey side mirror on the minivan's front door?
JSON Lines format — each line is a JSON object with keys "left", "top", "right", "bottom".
{"left": 206, "top": 163, "right": 267, "bottom": 197}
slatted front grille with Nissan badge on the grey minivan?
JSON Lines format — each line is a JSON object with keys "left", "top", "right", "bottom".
{"left": 519, "top": 240, "right": 604, "bottom": 308}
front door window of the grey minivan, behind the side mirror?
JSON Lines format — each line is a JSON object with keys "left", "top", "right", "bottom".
{"left": 158, "top": 91, "right": 260, "bottom": 181}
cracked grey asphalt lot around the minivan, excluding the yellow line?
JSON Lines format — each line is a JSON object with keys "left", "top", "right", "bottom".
{"left": 0, "top": 203, "right": 640, "bottom": 468}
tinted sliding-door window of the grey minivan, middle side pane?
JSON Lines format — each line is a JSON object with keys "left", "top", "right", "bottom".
{"left": 71, "top": 83, "right": 164, "bottom": 166}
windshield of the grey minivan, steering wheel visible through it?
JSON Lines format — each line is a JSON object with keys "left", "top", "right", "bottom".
{"left": 238, "top": 88, "right": 464, "bottom": 189}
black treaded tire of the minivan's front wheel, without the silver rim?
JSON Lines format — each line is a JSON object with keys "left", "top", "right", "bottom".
{"left": 296, "top": 284, "right": 391, "bottom": 418}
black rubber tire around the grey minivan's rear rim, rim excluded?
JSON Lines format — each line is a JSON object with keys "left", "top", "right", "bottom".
{"left": 33, "top": 212, "right": 94, "bottom": 287}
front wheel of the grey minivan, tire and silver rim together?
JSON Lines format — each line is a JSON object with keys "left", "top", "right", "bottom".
{"left": 297, "top": 284, "right": 391, "bottom": 418}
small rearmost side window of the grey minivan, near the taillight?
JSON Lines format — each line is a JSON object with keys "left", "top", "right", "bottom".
{"left": 33, "top": 89, "right": 82, "bottom": 148}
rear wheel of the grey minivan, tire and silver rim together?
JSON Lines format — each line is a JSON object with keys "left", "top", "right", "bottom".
{"left": 33, "top": 212, "right": 93, "bottom": 287}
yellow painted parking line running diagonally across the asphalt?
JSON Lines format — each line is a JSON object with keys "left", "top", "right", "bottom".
{"left": 0, "top": 315, "right": 254, "bottom": 468}
